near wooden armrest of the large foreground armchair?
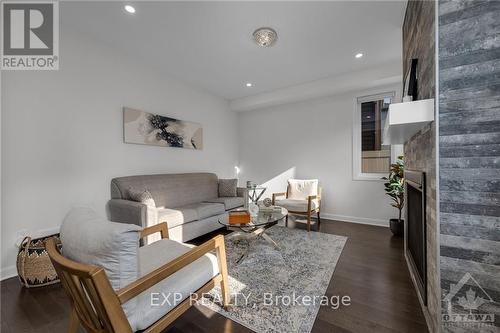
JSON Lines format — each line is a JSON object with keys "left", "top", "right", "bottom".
{"left": 116, "top": 233, "right": 226, "bottom": 304}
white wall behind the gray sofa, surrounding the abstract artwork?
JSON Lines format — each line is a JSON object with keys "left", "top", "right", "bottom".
{"left": 1, "top": 29, "right": 238, "bottom": 277}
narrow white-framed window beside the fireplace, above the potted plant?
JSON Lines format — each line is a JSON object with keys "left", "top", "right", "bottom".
{"left": 353, "top": 92, "right": 395, "bottom": 180}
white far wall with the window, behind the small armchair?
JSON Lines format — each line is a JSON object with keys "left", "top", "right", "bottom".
{"left": 238, "top": 87, "right": 397, "bottom": 225}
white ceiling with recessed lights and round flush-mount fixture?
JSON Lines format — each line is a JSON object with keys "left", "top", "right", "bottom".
{"left": 61, "top": 1, "right": 406, "bottom": 100}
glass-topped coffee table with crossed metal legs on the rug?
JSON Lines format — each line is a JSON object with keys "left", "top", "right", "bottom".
{"left": 219, "top": 207, "right": 288, "bottom": 263}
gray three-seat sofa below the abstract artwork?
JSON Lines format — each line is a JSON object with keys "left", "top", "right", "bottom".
{"left": 108, "top": 173, "right": 247, "bottom": 242}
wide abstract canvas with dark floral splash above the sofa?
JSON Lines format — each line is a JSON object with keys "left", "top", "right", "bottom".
{"left": 123, "top": 107, "right": 203, "bottom": 150}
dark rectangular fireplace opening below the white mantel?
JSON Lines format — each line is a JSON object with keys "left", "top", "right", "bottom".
{"left": 405, "top": 170, "right": 427, "bottom": 305}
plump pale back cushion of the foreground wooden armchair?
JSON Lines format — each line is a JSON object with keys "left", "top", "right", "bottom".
{"left": 60, "top": 207, "right": 141, "bottom": 315}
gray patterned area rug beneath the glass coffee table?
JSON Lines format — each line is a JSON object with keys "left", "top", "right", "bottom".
{"left": 200, "top": 225, "right": 347, "bottom": 333}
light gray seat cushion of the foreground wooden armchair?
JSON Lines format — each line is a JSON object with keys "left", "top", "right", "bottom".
{"left": 128, "top": 239, "right": 219, "bottom": 331}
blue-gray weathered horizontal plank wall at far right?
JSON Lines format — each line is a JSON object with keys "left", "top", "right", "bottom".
{"left": 438, "top": 1, "right": 500, "bottom": 332}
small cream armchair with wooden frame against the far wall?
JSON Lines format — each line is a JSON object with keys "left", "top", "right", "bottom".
{"left": 273, "top": 179, "right": 321, "bottom": 231}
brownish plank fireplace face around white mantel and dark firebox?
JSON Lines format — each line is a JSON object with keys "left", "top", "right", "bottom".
{"left": 403, "top": 1, "right": 441, "bottom": 332}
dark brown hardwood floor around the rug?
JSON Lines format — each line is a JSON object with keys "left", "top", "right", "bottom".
{"left": 1, "top": 220, "right": 427, "bottom": 333}
